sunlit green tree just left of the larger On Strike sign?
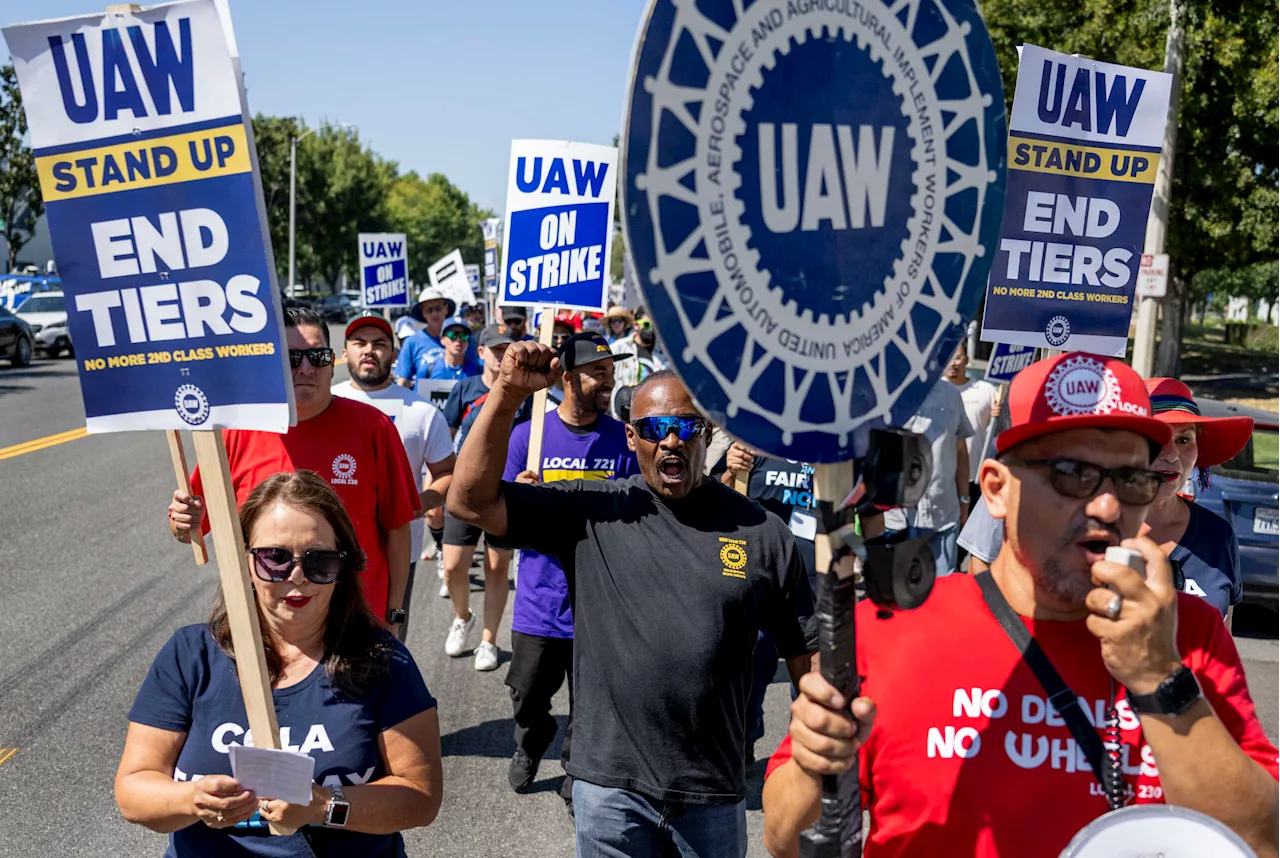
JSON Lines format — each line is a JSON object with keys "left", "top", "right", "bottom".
{"left": 387, "top": 172, "right": 494, "bottom": 284}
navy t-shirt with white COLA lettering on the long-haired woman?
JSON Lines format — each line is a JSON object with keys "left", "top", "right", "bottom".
{"left": 129, "top": 625, "right": 435, "bottom": 858}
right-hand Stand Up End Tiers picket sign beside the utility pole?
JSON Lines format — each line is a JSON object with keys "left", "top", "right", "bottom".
{"left": 982, "top": 45, "right": 1172, "bottom": 356}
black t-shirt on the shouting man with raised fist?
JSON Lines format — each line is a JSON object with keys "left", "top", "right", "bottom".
{"left": 503, "top": 475, "right": 810, "bottom": 804}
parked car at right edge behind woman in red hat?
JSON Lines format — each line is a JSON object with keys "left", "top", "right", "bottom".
{"left": 1196, "top": 398, "right": 1280, "bottom": 610}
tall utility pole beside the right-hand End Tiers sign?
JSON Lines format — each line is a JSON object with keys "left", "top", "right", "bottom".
{"left": 1133, "top": 0, "right": 1187, "bottom": 378}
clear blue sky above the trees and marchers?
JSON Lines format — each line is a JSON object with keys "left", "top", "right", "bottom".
{"left": 0, "top": 0, "right": 645, "bottom": 214}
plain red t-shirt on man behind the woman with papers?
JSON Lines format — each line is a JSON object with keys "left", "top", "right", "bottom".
{"left": 191, "top": 397, "right": 422, "bottom": 620}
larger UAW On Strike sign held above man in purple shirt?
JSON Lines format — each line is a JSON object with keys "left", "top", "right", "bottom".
{"left": 498, "top": 140, "right": 618, "bottom": 311}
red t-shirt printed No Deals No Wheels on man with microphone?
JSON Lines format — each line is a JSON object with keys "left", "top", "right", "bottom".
{"left": 765, "top": 575, "right": 1280, "bottom": 858}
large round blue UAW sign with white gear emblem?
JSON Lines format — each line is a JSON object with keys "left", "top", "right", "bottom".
{"left": 623, "top": 0, "right": 1006, "bottom": 462}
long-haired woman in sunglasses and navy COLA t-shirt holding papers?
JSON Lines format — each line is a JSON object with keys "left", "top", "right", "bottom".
{"left": 115, "top": 470, "right": 442, "bottom": 857}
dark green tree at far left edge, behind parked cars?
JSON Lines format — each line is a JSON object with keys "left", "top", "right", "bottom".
{"left": 0, "top": 63, "right": 45, "bottom": 271}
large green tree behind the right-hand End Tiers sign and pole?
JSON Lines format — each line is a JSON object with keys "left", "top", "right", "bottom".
{"left": 982, "top": 0, "right": 1280, "bottom": 375}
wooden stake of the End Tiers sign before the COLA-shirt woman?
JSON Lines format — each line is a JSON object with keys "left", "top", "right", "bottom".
{"left": 191, "top": 429, "right": 293, "bottom": 835}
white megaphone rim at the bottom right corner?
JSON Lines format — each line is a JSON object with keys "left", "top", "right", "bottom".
{"left": 1061, "top": 804, "right": 1257, "bottom": 858}
